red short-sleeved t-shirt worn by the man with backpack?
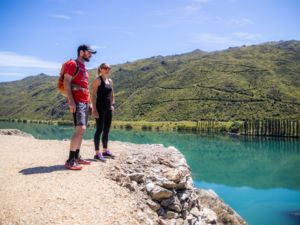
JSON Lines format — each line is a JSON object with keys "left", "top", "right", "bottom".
{"left": 65, "top": 60, "right": 90, "bottom": 102}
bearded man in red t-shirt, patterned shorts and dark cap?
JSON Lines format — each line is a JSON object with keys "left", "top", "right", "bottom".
{"left": 64, "top": 45, "right": 96, "bottom": 170}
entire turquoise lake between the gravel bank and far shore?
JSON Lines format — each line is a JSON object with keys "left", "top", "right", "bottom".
{"left": 0, "top": 122, "right": 300, "bottom": 225}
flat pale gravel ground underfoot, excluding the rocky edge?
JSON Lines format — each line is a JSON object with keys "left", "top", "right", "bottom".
{"left": 0, "top": 134, "right": 140, "bottom": 225}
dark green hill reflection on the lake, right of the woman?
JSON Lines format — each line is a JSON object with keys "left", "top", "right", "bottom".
{"left": 110, "top": 131, "right": 300, "bottom": 190}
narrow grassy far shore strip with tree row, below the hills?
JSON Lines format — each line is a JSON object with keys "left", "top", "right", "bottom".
{"left": 0, "top": 118, "right": 300, "bottom": 138}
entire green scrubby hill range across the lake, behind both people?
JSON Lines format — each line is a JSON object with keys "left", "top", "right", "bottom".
{"left": 0, "top": 41, "right": 300, "bottom": 121}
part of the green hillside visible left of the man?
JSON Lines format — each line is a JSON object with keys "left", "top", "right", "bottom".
{"left": 0, "top": 74, "right": 70, "bottom": 120}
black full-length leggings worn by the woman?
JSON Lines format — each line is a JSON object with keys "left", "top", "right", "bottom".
{"left": 94, "top": 110, "right": 112, "bottom": 151}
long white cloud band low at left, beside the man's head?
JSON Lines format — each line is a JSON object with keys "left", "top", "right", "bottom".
{"left": 0, "top": 51, "right": 61, "bottom": 69}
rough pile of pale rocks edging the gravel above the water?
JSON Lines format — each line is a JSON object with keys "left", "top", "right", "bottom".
{"left": 107, "top": 143, "right": 247, "bottom": 225}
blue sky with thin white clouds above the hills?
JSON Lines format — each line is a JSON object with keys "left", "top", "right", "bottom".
{"left": 0, "top": 0, "right": 300, "bottom": 82}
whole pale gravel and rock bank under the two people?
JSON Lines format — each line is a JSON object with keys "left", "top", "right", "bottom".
{"left": 0, "top": 130, "right": 246, "bottom": 225}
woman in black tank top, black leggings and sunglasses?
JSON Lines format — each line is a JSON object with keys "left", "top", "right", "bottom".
{"left": 92, "top": 63, "right": 115, "bottom": 161}
